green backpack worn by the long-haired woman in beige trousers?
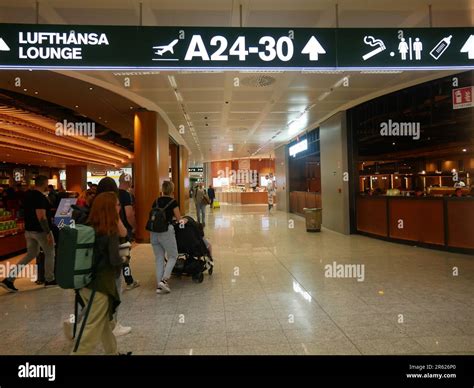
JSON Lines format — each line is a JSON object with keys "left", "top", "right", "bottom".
{"left": 56, "top": 224, "right": 95, "bottom": 290}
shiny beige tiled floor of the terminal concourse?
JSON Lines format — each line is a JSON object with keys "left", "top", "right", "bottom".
{"left": 0, "top": 205, "right": 474, "bottom": 355}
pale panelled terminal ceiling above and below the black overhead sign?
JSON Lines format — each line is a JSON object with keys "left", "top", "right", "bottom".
{"left": 0, "top": 0, "right": 473, "bottom": 161}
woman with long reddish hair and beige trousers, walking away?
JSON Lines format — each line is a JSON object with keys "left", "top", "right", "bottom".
{"left": 71, "top": 192, "right": 127, "bottom": 355}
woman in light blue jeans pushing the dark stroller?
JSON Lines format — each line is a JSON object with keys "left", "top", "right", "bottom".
{"left": 150, "top": 181, "right": 188, "bottom": 294}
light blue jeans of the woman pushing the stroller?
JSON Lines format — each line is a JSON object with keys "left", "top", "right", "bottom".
{"left": 150, "top": 225, "right": 178, "bottom": 283}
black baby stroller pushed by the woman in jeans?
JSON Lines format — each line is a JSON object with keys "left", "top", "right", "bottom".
{"left": 173, "top": 216, "right": 214, "bottom": 283}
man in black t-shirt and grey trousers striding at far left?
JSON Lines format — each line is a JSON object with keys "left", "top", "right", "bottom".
{"left": 0, "top": 175, "right": 57, "bottom": 292}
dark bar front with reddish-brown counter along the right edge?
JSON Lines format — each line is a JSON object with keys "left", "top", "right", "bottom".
{"left": 348, "top": 72, "right": 474, "bottom": 251}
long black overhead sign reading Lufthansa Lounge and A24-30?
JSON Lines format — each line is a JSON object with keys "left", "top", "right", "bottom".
{"left": 0, "top": 24, "right": 474, "bottom": 70}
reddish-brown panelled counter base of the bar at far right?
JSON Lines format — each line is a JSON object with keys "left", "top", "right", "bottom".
{"left": 357, "top": 196, "right": 474, "bottom": 252}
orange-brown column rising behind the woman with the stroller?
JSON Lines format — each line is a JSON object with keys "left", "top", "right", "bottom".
{"left": 134, "top": 110, "right": 169, "bottom": 242}
